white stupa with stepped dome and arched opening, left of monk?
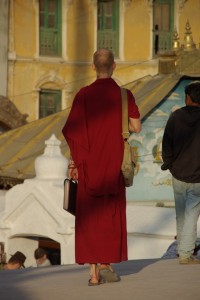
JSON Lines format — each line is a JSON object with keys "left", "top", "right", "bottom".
{"left": 0, "top": 135, "right": 74, "bottom": 266}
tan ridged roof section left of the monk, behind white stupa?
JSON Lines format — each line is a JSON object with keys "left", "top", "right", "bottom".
{"left": 0, "top": 109, "right": 69, "bottom": 179}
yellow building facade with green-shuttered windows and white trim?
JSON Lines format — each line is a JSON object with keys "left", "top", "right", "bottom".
{"left": 3, "top": 0, "right": 200, "bottom": 122}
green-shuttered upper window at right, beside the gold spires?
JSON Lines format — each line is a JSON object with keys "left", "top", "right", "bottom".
{"left": 153, "top": 0, "right": 174, "bottom": 56}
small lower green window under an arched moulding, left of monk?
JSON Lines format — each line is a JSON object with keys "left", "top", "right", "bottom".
{"left": 39, "top": 90, "right": 61, "bottom": 119}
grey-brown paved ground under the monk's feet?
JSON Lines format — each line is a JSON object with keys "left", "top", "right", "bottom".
{"left": 0, "top": 259, "right": 200, "bottom": 300}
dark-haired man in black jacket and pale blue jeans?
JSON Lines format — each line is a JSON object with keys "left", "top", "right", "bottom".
{"left": 161, "top": 81, "right": 200, "bottom": 264}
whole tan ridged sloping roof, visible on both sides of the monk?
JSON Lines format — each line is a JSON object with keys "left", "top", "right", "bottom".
{"left": 0, "top": 75, "right": 184, "bottom": 179}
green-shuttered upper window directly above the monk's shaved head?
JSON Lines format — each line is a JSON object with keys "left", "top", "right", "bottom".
{"left": 97, "top": 0, "right": 119, "bottom": 57}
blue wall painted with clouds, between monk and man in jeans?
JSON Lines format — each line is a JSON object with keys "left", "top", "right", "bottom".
{"left": 126, "top": 79, "right": 199, "bottom": 201}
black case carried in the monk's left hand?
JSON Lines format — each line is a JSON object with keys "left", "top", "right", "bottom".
{"left": 63, "top": 178, "right": 78, "bottom": 216}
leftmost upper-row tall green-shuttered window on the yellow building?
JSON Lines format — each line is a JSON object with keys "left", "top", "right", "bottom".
{"left": 39, "top": 0, "right": 61, "bottom": 56}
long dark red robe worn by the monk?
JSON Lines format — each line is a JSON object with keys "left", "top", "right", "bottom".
{"left": 63, "top": 78, "right": 140, "bottom": 264}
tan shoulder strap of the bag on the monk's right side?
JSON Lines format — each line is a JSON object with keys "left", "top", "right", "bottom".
{"left": 120, "top": 88, "right": 130, "bottom": 140}
